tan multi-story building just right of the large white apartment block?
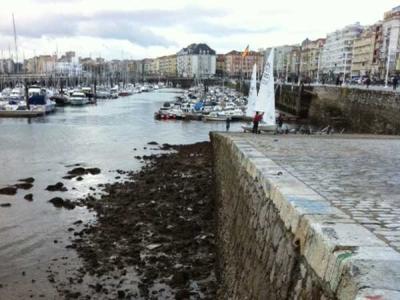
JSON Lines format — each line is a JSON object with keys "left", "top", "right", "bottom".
{"left": 351, "top": 23, "right": 382, "bottom": 77}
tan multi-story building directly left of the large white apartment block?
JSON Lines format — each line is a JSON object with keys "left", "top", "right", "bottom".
{"left": 299, "top": 39, "right": 325, "bottom": 81}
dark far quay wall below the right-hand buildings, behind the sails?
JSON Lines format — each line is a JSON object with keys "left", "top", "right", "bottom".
{"left": 276, "top": 85, "right": 400, "bottom": 134}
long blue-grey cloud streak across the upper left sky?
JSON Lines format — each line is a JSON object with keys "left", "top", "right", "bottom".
{"left": 0, "top": 5, "right": 228, "bottom": 47}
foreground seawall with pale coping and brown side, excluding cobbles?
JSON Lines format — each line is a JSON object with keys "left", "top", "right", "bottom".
{"left": 211, "top": 133, "right": 400, "bottom": 300}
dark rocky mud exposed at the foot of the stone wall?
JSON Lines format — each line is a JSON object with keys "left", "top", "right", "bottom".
{"left": 49, "top": 143, "right": 217, "bottom": 299}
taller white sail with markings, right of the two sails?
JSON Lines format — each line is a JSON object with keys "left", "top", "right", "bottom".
{"left": 255, "top": 49, "right": 276, "bottom": 125}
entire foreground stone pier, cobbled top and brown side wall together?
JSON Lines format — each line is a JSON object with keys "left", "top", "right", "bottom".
{"left": 211, "top": 133, "right": 400, "bottom": 300}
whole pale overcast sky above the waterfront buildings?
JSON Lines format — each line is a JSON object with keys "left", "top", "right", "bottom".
{"left": 0, "top": 0, "right": 399, "bottom": 59}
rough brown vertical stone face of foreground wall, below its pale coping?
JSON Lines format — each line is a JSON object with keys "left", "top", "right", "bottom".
{"left": 213, "top": 137, "right": 334, "bottom": 300}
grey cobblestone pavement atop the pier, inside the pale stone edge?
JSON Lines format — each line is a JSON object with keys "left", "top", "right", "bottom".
{"left": 233, "top": 133, "right": 400, "bottom": 252}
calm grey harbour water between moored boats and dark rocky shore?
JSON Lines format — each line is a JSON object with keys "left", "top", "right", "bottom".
{"left": 0, "top": 90, "right": 240, "bottom": 299}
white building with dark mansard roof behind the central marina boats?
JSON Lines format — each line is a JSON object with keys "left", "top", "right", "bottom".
{"left": 176, "top": 44, "right": 217, "bottom": 78}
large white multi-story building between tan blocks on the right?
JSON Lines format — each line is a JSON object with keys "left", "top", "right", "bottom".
{"left": 321, "top": 23, "right": 363, "bottom": 77}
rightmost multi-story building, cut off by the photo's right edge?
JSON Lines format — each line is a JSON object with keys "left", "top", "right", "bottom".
{"left": 381, "top": 5, "right": 400, "bottom": 75}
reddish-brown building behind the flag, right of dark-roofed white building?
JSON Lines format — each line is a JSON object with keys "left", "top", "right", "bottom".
{"left": 225, "top": 50, "right": 264, "bottom": 79}
